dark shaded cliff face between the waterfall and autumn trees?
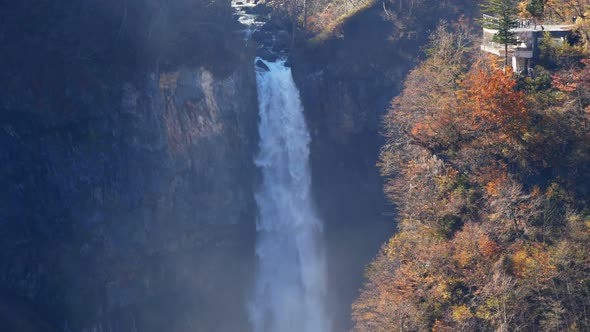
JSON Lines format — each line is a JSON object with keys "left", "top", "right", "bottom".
{"left": 293, "top": 6, "right": 430, "bottom": 331}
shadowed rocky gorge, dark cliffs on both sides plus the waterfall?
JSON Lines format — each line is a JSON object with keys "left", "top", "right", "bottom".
{"left": 0, "top": 0, "right": 480, "bottom": 332}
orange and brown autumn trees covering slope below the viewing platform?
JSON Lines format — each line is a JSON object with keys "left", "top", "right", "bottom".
{"left": 353, "top": 21, "right": 590, "bottom": 332}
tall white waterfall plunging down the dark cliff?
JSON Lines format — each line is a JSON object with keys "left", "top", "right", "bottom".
{"left": 249, "top": 59, "right": 330, "bottom": 332}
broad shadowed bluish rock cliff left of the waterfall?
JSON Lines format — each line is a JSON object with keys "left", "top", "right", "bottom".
{"left": 0, "top": 1, "right": 257, "bottom": 331}
